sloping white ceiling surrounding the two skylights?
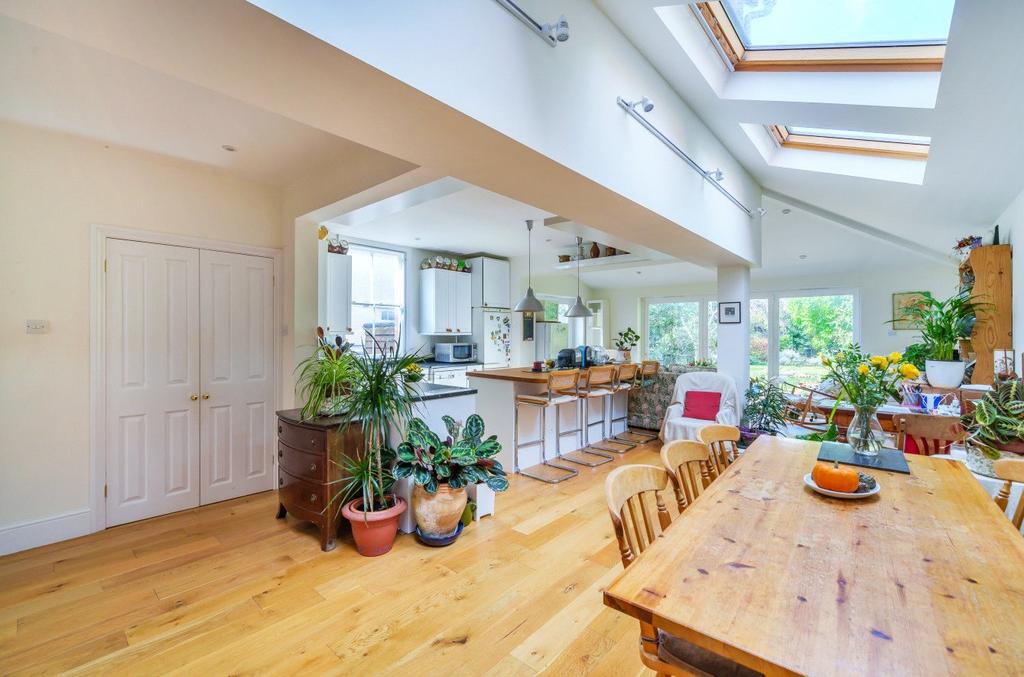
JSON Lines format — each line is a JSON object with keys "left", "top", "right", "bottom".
{"left": 594, "top": 0, "right": 1024, "bottom": 247}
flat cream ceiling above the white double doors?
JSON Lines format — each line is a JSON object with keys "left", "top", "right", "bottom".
{"left": 0, "top": 16, "right": 391, "bottom": 185}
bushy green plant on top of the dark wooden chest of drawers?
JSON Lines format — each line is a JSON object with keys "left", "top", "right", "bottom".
{"left": 295, "top": 327, "right": 355, "bottom": 421}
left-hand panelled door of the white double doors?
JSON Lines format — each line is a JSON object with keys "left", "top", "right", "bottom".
{"left": 103, "top": 240, "right": 200, "bottom": 525}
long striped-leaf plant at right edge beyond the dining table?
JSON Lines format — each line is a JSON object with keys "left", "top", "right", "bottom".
{"left": 961, "top": 380, "right": 1024, "bottom": 477}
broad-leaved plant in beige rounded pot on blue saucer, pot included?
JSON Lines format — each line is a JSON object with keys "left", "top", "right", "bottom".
{"left": 394, "top": 414, "right": 509, "bottom": 542}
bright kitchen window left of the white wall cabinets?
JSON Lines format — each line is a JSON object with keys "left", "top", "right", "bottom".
{"left": 346, "top": 245, "right": 406, "bottom": 351}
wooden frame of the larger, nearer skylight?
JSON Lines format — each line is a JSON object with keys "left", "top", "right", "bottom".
{"left": 694, "top": 0, "right": 946, "bottom": 72}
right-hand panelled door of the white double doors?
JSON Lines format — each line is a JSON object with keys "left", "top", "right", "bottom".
{"left": 200, "top": 250, "right": 274, "bottom": 504}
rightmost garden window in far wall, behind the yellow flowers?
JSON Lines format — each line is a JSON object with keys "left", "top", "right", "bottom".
{"left": 778, "top": 294, "right": 854, "bottom": 385}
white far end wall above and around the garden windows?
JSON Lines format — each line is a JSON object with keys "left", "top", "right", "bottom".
{"left": 591, "top": 263, "right": 956, "bottom": 362}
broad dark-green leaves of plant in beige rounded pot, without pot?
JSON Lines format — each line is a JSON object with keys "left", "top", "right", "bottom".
{"left": 394, "top": 414, "right": 509, "bottom": 494}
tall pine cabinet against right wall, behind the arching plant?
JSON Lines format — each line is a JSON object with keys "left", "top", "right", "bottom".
{"left": 959, "top": 245, "right": 1014, "bottom": 385}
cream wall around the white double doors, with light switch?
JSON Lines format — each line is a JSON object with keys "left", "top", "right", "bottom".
{"left": 0, "top": 123, "right": 288, "bottom": 532}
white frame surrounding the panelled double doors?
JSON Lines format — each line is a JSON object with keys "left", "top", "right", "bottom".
{"left": 89, "top": 223, "right": 284, "bottom": 533}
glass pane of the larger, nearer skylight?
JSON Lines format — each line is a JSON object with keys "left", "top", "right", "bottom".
{"left": 722, "top": 0, "right": 953, "bottom": 49}
